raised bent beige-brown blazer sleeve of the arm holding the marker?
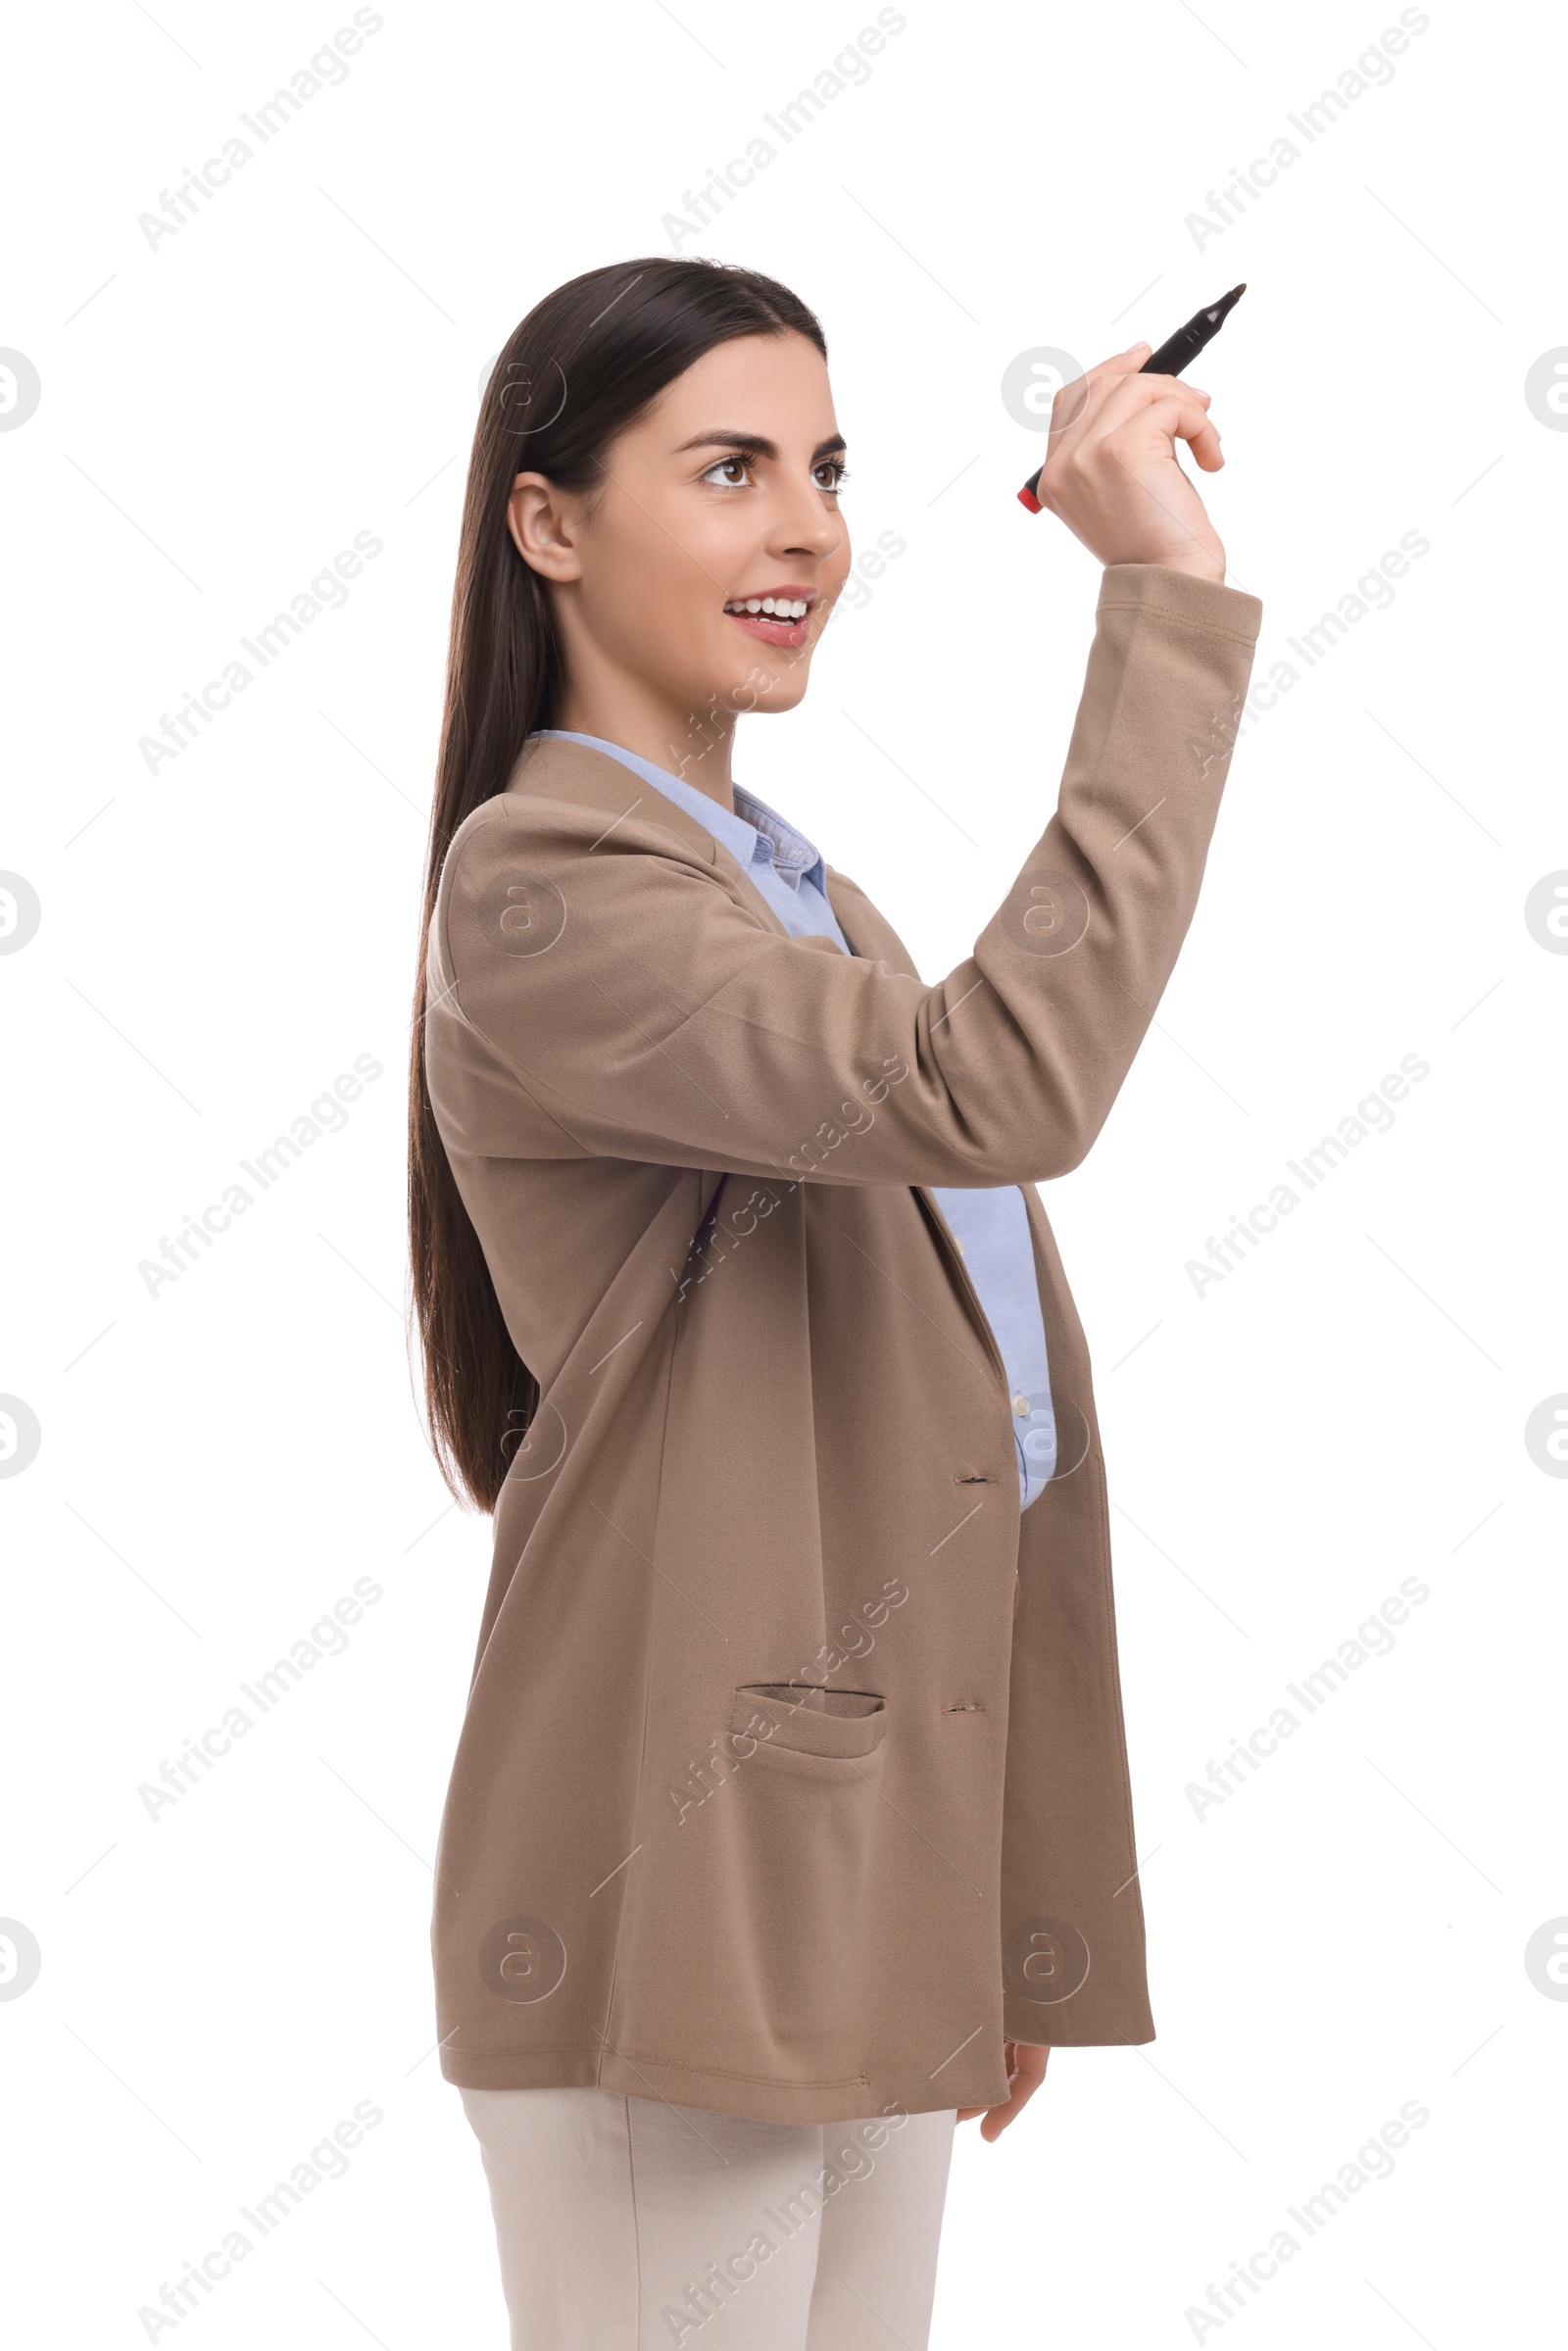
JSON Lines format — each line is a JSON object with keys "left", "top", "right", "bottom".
{"left": 432, "top": 564, "right": 1262, "bottom": 1185}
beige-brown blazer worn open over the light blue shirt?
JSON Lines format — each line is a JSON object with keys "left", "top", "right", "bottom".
{"left": 428, "top": 564, "right": 1262, "bottom": 2123}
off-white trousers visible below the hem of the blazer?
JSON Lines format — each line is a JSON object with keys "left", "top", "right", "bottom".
{"left": 461, "top": 2090, "right": 955, "bottom": 2351}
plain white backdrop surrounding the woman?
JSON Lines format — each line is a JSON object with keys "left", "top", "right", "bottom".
{"left": 0, "top": 0, "right": 1568, "bottom": 2351}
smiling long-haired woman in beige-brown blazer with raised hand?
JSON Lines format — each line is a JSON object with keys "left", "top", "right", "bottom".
{"left": 412, "top": 259, "right": 1260, "bottom": 2351}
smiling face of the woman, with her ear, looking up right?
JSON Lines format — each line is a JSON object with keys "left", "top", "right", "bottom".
{"left": 511, "top": 334, "right": 849, "bottom": 757}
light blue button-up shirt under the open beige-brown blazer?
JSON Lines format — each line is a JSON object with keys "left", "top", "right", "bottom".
{"left": 538, "top": 726, "right": 1055, "bottom": 1509}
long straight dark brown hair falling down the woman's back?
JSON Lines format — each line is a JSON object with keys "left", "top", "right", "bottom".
{"left": 409, "top": 254, "right": 827, "bottom": 1509}
